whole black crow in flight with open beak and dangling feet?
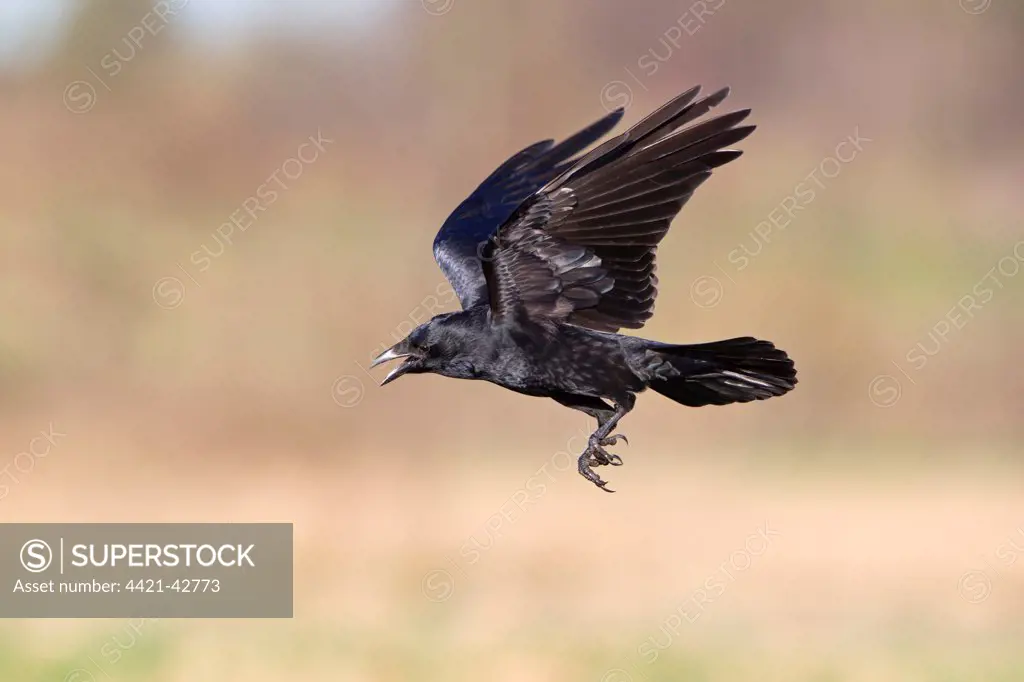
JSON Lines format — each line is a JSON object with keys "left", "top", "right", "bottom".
{"left": 371, "top": 87, "right": 797, "bottom": 492}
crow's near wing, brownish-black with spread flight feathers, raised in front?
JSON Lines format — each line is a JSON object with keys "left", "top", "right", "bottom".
{"left": 482, "top": 87, "right": 754, "bottom": 331}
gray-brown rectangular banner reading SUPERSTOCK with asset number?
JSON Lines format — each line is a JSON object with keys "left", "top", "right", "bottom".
{"left": 0, "top": 523, "right": 292, "bottom": 619}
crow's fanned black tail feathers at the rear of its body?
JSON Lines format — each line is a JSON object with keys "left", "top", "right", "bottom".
{"left": 647, "top": 336, "right": 797, "bottom": 408}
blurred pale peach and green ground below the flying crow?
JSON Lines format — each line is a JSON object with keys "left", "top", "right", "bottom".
{"left": 0, "top": 450, "right": 1024, "bottom": 682}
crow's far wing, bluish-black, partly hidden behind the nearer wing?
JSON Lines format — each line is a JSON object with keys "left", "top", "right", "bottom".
{"left": 434, "top": 109, "right": 623, "bottom": 308}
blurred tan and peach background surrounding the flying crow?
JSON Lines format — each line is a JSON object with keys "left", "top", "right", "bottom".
{"left": 0, "top": 0, "right": 1024, "bottom": 682}
